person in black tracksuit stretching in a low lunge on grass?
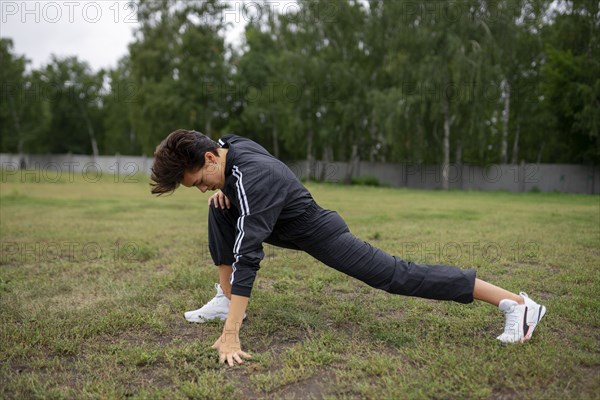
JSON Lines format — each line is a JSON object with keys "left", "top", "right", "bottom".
{"left": 151, "top": 130, "right": 546, "bottom": 366}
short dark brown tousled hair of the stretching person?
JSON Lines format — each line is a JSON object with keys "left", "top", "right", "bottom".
{"left": 150, "top": 129, "right": 219, "bottom": 196}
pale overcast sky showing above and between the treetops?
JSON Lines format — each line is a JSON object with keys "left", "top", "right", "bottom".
{"left": 0, "top": 0, "right": 262, "bottom": 71}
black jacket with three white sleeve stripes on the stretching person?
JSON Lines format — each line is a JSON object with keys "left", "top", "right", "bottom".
{"left": 219, "top": 135, "right": 314, "bottom": 297}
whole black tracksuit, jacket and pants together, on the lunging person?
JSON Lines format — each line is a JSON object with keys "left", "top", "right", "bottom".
{"left": 209, "top": 135, "right": 475, "bottom": 303}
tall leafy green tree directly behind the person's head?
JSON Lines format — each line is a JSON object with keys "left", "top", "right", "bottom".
{"left": 130, "top": 0, "right": 229, "bottom": 154}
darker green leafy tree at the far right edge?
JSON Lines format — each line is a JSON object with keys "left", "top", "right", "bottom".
{"left": 541, "top": 1, "right": 600, "bottom": 164}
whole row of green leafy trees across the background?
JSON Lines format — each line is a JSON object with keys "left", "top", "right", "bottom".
{"left": 0, "top": 0, "right": 600, "bottom": 171}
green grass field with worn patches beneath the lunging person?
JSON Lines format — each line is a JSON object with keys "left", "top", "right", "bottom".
{"left": 0, "top": 175, "right": 600, "bottom": 399}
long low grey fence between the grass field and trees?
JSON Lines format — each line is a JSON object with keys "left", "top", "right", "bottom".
{"left": 0, "top": 154, "right": 600, "bottom": 194}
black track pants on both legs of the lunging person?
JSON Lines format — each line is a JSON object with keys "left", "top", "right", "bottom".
{"left": 208, "top": 204, "right": 475, "bottom": 303}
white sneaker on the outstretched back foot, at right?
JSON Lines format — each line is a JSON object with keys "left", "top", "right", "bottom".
{"left": 497, "top": 292, "right": 546, "bottom": 343}
